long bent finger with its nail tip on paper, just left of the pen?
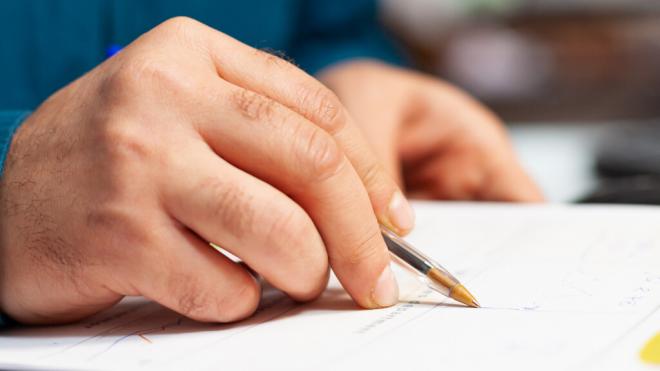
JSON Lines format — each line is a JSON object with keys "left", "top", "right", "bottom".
{"left": 192, "top": 82, "right": 398, "bottom": 307}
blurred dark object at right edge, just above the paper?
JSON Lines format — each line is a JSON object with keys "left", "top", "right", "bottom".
{"left": 578, "top": 122, "right": 660, "bottom": 205}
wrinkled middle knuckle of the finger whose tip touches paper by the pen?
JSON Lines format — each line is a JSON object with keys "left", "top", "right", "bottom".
{"left": 297, "top": 128, "right": 346, "bottom": 182}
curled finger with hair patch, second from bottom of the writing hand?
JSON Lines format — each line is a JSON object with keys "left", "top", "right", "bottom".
{"left": 164, "top": 148, "right": 328, "bottom": 300}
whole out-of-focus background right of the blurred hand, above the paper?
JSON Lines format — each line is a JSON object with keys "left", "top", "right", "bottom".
{"left": 380, "top": 0, "right": 660, "bottom": 204}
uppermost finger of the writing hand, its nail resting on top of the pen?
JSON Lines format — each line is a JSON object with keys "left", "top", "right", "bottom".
{"left": 195, "top": 24, "right": 414, "bottom": 234}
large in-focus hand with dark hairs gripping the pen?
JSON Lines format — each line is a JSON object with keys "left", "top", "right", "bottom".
{"left": 0, "top": 18, "right": 413, "bottom": 323}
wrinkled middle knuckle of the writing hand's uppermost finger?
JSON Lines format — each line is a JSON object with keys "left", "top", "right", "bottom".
{"left": 300, "top": 86, "right": 346, "bottom": 135}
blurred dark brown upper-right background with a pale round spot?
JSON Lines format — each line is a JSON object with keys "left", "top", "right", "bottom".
{"left": 381, "top": 0, "right": 660, "bottom": 121}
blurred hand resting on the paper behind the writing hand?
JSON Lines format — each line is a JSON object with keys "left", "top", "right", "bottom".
{"left": 320, "top": 61, "right": 543, "bottom": 202}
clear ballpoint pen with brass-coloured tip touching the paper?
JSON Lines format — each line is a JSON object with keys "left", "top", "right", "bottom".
{"left": 380, "top": 225, "right": 480, "bottom": 308}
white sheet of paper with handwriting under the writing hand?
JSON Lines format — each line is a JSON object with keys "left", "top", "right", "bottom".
{"left": 0, "top": 203, "right": 660, "bottom": 370}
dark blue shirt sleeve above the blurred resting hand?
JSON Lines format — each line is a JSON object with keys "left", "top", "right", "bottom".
{"left": 290, "top": 0, "right": 407, "bottom": 74}
